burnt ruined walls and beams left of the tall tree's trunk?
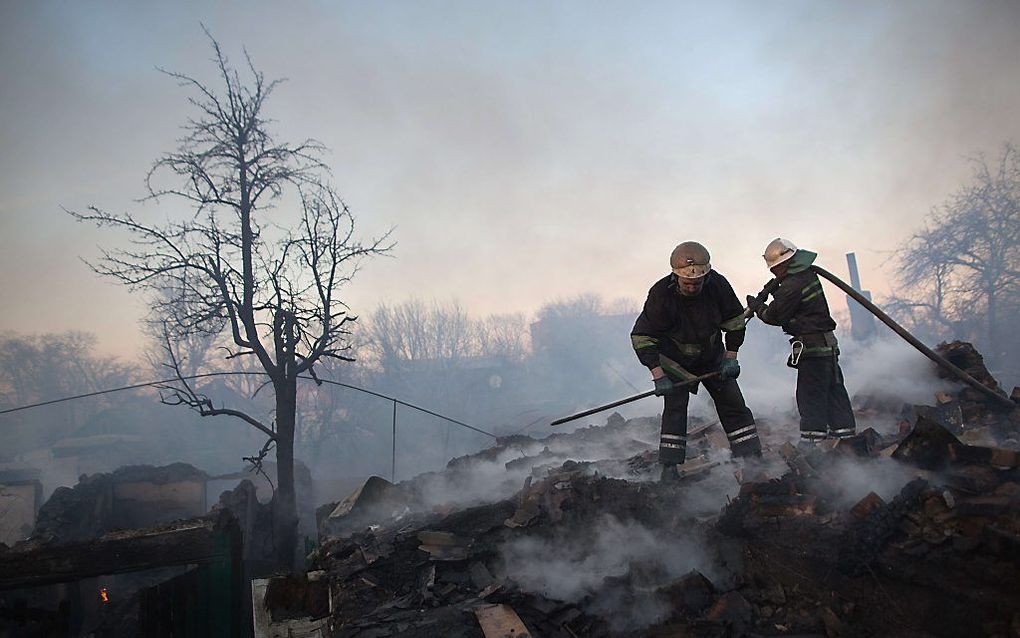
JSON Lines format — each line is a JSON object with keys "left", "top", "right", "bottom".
{"left": 0, "top": 462, "right": 272, "bottom": 636}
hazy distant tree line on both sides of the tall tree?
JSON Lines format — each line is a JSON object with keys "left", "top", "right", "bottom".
{"left": 0, "top": 293, "right": 643, "bottom": 477}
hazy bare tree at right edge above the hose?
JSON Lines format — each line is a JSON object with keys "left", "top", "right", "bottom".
{"left": 897, "top": 144, "right": 1020, "bottom": 371}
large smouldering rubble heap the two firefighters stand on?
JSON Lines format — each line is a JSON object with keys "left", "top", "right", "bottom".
{"left": 309, "top": 342, "right": 1020, "bottom": 638}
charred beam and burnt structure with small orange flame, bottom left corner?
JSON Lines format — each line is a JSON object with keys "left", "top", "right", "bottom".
{"left": 0, "top": 510, "right": 244, "bottom": 638}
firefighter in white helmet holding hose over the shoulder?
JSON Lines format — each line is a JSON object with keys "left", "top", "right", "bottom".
{"left": 748, "top": 238, "right": 857, "bottom": 443}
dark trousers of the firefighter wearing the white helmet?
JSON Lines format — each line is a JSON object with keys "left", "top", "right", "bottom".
{"left": 797, "top": 356, "right": 857, "bottom": 441}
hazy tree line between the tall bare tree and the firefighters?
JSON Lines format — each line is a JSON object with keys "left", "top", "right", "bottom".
{"left": 300, "top": 293, "right": 638, "bottom": 477}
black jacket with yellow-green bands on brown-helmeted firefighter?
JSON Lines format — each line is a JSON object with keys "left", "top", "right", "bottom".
{"left": 630, "top": 271, "right": 745, "bottom": 377}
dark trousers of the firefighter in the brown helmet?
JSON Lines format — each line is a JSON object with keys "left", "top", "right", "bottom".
{"left": 659, "top": 379, "right": 762, "bottom": 464}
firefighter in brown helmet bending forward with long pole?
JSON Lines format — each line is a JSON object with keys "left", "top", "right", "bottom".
{"left": 630, "top": 242, "right": 761, "bottom": 480}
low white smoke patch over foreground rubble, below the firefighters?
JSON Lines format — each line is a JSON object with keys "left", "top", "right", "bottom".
{"left": 500, "top": 514, "right": 723, "bottom": 631}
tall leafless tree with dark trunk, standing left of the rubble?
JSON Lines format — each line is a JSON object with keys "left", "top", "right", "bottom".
{"left": 70, "top": 37, "right": 391, "bottom": 565}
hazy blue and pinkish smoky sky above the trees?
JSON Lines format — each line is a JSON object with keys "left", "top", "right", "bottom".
{"left": 0, "top": 0, "right": 1020, "bottom": 354}
